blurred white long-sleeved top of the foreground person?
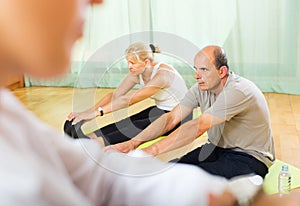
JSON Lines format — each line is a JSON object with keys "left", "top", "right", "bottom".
{"left": 0, "top": 89, "right": 227, "bottom": 206}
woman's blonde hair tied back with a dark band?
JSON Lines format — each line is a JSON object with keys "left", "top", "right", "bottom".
{"left": 125, "top": 42, "right": 160, "bottom": 62}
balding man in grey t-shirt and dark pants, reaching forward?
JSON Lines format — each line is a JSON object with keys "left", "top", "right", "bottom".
{"left": 110, "top": 45, "right": 275, "bottom": 179}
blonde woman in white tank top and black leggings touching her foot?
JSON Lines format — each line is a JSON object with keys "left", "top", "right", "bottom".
{"left": 64, "top": 42, "right": 191, "bottom": 145}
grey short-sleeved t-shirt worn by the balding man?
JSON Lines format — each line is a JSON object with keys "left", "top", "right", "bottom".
{"left": 180, "top": 73, "right": 275, "bottom": 167}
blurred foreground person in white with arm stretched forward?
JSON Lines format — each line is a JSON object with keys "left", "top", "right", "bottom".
{"left": 0, "top": 0, "right": 299, "bottom": 206}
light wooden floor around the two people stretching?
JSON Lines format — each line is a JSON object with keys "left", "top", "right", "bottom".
{"left": 13, "top": 87, "right": 300, "bottom": 168}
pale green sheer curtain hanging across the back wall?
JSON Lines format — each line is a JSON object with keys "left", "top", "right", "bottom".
{"left": 26, "top": 0, "right": 300, "bottom": 94}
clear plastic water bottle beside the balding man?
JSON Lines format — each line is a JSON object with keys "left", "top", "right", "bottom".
{"left": 278, "top": 165, "right": 291, "bottom": 196}
